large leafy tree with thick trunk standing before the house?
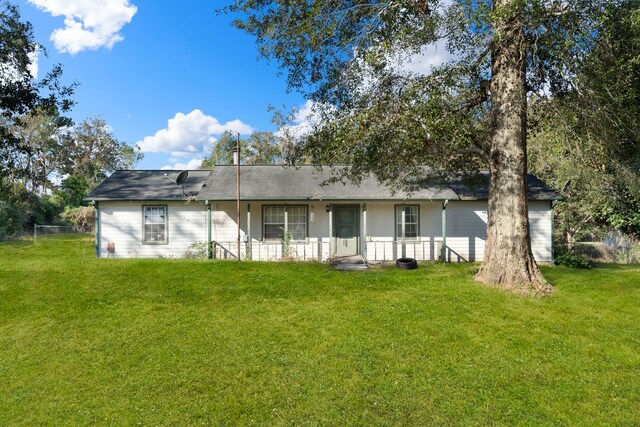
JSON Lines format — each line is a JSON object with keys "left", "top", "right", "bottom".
{"left": 226, "top": 0, "right": 612, "bottom": 293}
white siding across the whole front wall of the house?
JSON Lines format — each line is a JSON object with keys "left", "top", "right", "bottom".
{"left": 99, "top": 201, "right": 552, "bottom": 262}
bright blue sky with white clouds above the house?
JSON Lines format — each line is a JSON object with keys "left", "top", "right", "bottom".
{"left": 17, "top": 0, "right": 305, "bottom": 169}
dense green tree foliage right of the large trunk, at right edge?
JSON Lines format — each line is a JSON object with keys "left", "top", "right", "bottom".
{"left": 529, "top": 0, "right": 640, "bottom": 248}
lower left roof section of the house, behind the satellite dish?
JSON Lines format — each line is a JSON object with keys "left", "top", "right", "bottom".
{"left": 85, "top": 170, "right": 209, "bottom": 201}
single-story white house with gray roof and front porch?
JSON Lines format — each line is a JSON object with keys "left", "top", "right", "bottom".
{"left": 87, "top": 166, "right": 558, "bottom": 262}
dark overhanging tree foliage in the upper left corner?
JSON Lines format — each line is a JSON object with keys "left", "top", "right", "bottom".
{"left": 0, "top": 2, "right": 76, "bottom": 176}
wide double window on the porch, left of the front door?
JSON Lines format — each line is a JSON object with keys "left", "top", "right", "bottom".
{"left": 262, "top": 205, "right": 307, "bottom": 240}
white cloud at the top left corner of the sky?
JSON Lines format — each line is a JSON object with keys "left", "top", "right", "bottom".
{"left": 28, "top": 0, "right": 138, "bottom": 55}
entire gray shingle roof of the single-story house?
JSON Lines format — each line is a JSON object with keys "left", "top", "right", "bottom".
{"left": 86, "top": 166, "right": 560, "bottom": 201}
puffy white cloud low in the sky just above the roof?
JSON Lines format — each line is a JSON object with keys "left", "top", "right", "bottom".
{"left": 137, "top": 109, "right": 253, "bottom": 157}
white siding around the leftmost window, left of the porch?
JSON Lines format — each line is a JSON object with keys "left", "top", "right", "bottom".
{"left": 99, "top": 202, "right": 207, "bottom": 258}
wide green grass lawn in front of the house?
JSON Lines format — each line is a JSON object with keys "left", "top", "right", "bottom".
{"left": 0, "top": 238, "right": 640, "bottom": 426}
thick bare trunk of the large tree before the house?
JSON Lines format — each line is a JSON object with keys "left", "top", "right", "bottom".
{"left": 475, "top": 0, "right": 552, "bottom": 294}
